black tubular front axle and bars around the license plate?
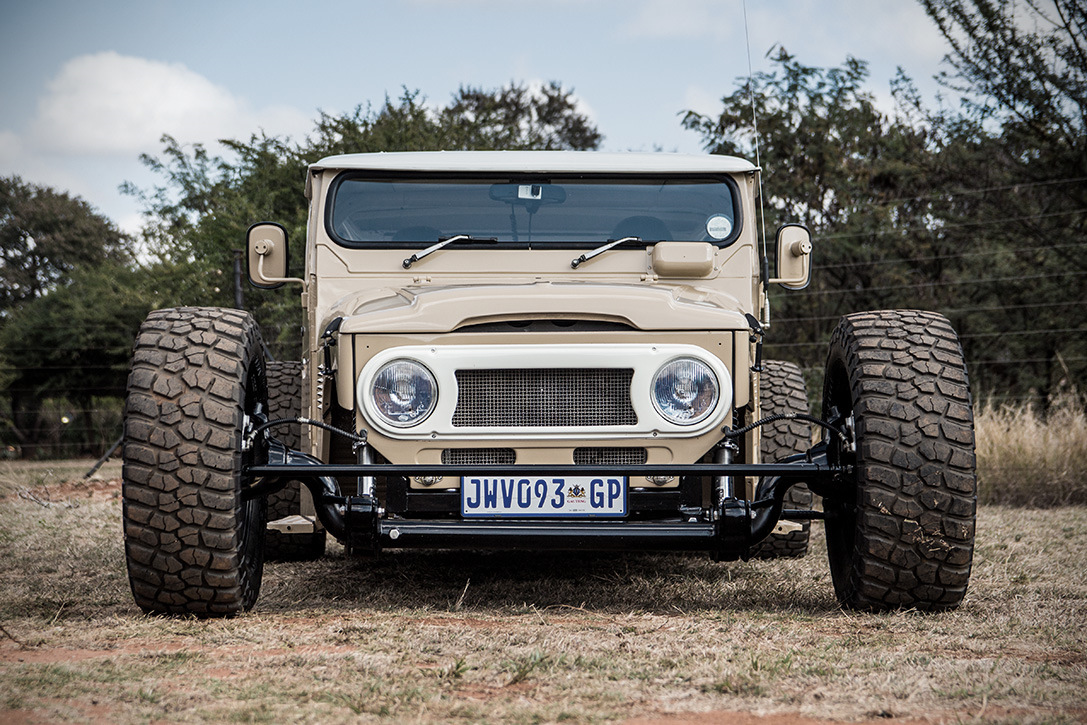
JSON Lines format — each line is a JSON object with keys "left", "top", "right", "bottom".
{"left": 246, "top": 456, "right": 851, "bottom": 560}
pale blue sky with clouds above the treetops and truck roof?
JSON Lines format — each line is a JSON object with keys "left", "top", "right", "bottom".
{"left": 0, "top": 0, "right": 946, "bottom": 230}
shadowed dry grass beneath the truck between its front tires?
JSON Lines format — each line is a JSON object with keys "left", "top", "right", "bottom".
{"left": 258, "top": 549, "right": 837, "bottom": 613}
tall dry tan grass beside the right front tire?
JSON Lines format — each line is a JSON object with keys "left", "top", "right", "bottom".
{"left": 976, "top": 392, "right": 1087, "bottom": 507}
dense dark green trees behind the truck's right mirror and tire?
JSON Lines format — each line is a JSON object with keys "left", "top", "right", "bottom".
{"left": 685, "top": 33, "right": 1087, "bottom": 406}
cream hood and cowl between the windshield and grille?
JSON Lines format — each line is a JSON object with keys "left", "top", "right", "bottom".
{"left": 316, "top": 245, "right": 753, "bottom": 333}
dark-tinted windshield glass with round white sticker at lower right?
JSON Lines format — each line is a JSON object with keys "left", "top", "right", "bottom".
{"left": 329, "top": 176, "right": 737, "bottom": 247}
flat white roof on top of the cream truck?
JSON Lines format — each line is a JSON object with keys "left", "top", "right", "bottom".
{"left": 310, "top": 151, "right": 755, "bottom": 174}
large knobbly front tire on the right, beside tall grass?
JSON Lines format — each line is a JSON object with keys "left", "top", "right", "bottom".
{"left": 823, "top": 311, "right": 977, "bottom": 611}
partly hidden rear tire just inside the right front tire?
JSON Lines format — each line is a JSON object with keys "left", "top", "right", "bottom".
{"left": 751, "top": 360, "right": 812, "bottom": 559}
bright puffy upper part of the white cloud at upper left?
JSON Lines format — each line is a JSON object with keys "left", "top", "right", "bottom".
{"left": 27, "top": 52, "right": 309, "bottom": 157}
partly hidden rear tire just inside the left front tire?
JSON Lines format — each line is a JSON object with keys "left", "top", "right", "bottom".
{"left": 264, "top": 362, "right": 326, "bottom": 561}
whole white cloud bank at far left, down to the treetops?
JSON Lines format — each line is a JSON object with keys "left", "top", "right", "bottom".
{"left": 0, "top": 52, "right": 312, "bottom": 232}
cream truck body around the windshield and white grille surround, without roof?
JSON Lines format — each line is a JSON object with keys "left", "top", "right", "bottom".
{"left": 303, "top": 163, "right": 762, "bottom": 463}
